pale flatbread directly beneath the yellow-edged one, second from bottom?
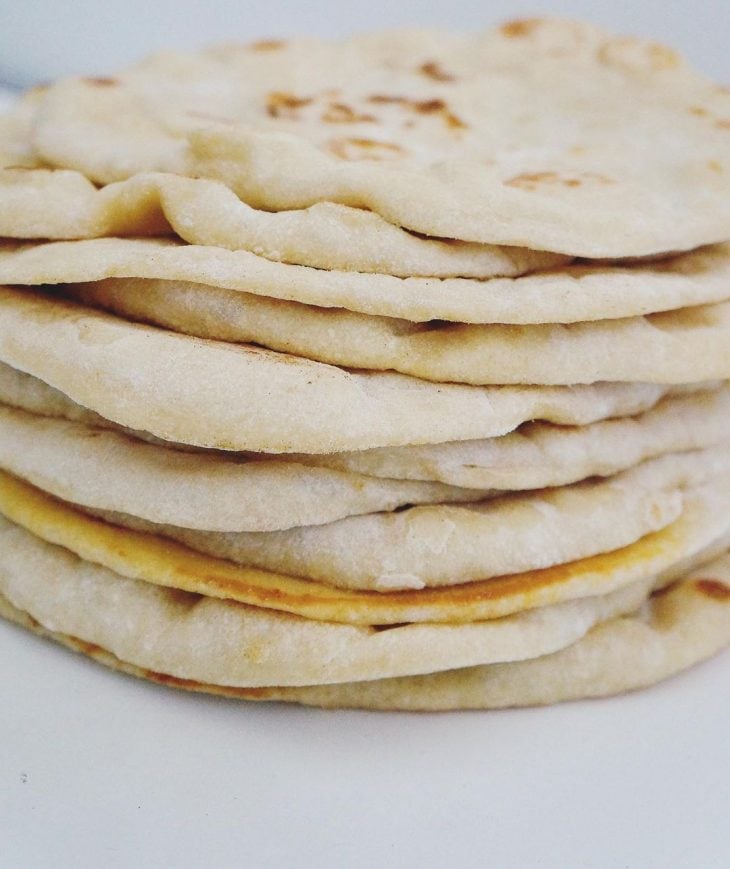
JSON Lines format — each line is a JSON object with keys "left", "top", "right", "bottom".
{"left": 0, "top": 519, "right": 653, "bottom": 685}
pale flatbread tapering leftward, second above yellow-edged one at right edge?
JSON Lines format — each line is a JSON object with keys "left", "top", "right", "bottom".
{"left": 300, "top": 384, "right": 730, "bottom": 490}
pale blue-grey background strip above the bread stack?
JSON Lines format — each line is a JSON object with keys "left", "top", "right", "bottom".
{"left": 0, "top": 0, "right": 730, "bottom": 84}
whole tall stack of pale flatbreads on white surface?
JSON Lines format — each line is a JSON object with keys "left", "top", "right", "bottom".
{"left": 0, "top": 21, "right": 730, "bottom": 709}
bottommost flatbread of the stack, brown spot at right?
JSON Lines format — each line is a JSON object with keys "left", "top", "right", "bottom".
{"left": 229, "top": 556, "right": 730, "bottom": 711}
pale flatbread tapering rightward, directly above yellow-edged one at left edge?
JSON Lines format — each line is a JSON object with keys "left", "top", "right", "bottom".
{"left": 0, "top": 405, "right": 485, "bottom": 531}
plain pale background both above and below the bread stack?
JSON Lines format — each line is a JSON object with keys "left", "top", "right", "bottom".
{"left": 0, "top": 0, "right": 730, "bottom": 869}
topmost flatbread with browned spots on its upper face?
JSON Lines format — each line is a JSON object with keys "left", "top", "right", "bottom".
{"left": 28, "top": 20, "right": 730, "bottom": 257}
